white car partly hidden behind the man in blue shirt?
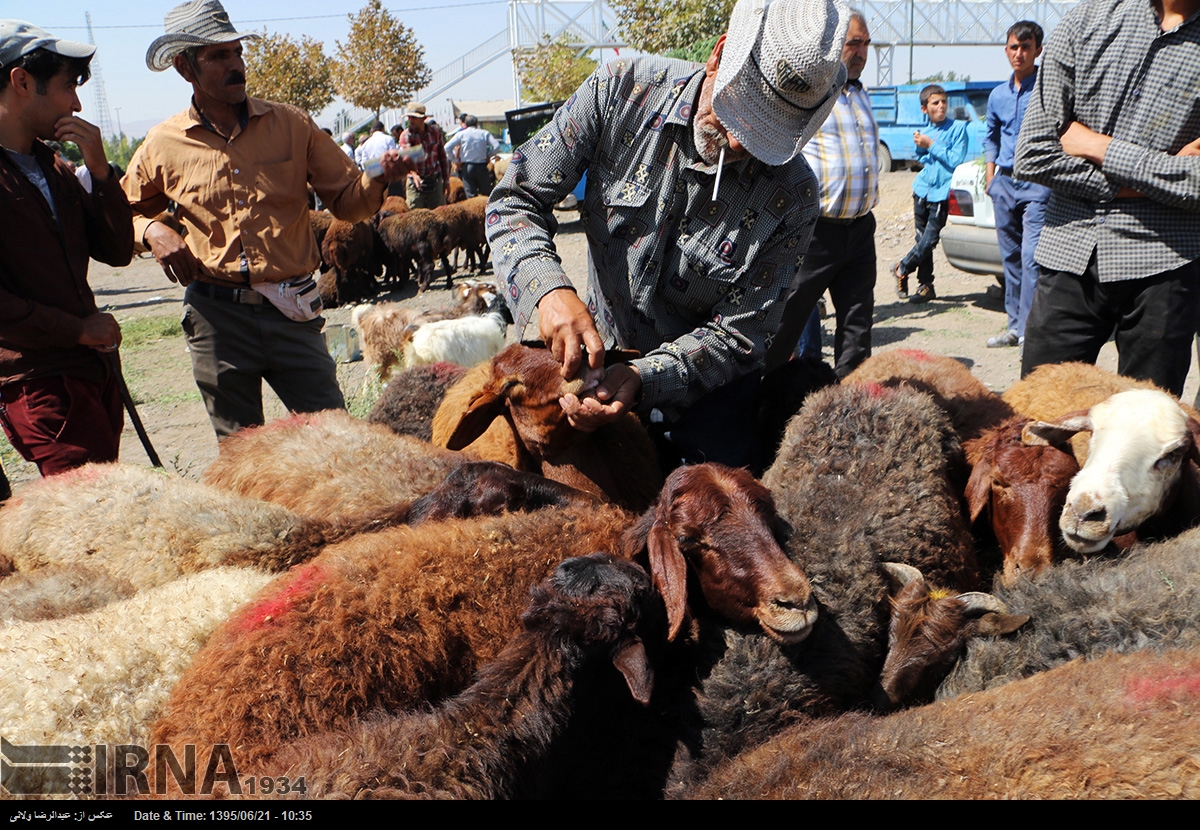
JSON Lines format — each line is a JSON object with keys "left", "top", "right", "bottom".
{"left": 942, "top": 158, "right": 1004, "bottom": 278}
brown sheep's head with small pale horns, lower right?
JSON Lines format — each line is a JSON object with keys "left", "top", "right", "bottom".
{"left": 871, "top": 563, "right": 1030, "bottom": 711}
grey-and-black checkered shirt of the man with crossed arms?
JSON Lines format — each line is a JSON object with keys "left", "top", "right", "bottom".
{"left": 1015, "top": 0, "right": 1200, "bottom": 282}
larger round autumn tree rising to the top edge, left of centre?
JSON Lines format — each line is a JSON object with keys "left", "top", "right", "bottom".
{"left": 336, "top": 0, "right": 432, "bottom": 118}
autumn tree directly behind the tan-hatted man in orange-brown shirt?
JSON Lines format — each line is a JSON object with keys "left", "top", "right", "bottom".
{"left": 246, "top": 29, "right": 334, "bottom": 115}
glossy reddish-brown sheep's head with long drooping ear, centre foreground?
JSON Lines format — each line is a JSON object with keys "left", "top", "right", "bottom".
{"left": 626, "top": 464, "right": 817, "bottom": 643}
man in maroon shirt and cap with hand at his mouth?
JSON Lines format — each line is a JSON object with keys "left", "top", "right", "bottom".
{"left": 0, "top": 20, "right": 133, "bottom": 475}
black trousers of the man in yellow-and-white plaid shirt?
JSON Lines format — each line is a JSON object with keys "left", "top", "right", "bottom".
{"left": 767, "top": 213, "right": 876, "bottom": 378}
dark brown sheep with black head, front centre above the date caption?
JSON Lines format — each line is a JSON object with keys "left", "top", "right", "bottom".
{"left": 240, "top": 553, "right": 661, "bottom": 799}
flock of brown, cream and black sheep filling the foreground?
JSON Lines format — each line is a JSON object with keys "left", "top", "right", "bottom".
{"left": 0, "top": 319, "right": 1200, "bottom": 799}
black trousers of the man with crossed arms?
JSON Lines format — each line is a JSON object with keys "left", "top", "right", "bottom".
{"left": 1021, "top": 254, "right": 1200, "bottom": 397}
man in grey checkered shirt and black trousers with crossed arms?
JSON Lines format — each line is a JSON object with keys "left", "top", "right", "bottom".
{"left": 1015, "top": 0, "right": 1200, "bottom": 395}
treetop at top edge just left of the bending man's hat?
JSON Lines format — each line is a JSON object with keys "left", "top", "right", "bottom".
{"left": 610, "top": 0, "right": 734, "bottom": 60}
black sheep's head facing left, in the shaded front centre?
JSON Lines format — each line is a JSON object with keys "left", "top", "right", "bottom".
{"left": 521, "top": 553, "right": 662, "bottom": 704}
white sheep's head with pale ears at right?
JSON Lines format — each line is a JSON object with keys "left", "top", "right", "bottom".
{"left": 1026, "top": 390, "right": 1200, "bottom": 553}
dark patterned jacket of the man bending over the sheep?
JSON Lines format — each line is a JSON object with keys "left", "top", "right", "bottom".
{"left": 487, "top": 58, "right": 818, "bottom": 420}
